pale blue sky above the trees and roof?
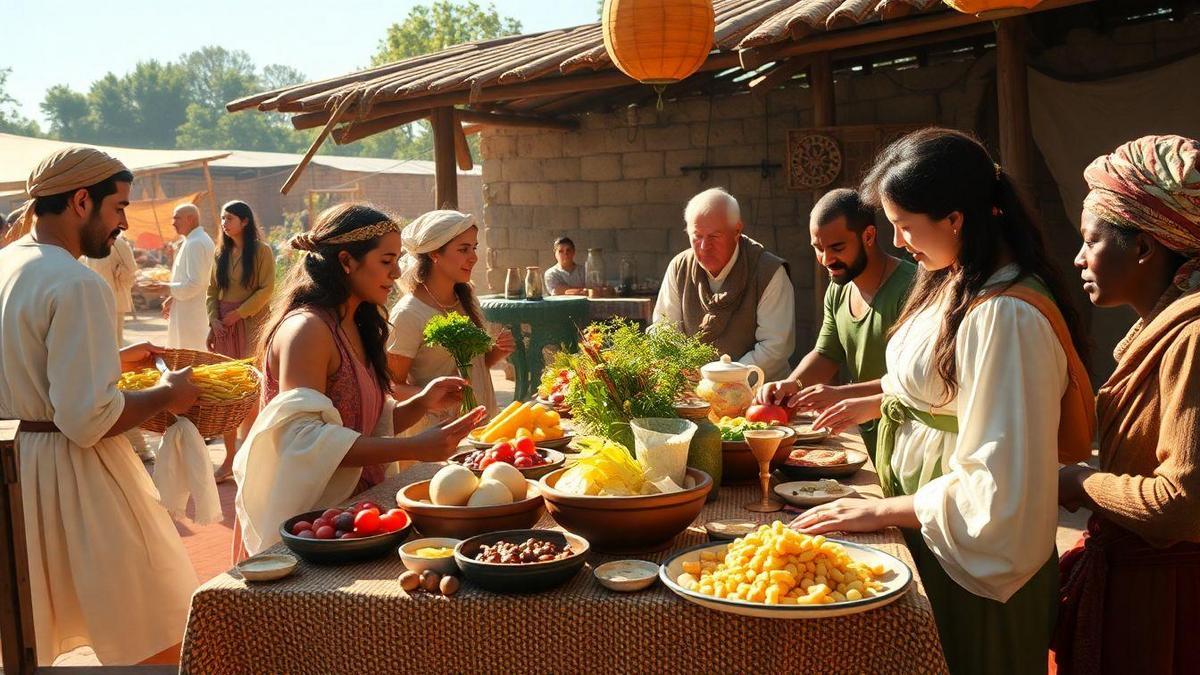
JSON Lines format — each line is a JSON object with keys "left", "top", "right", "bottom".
{"left": 0, "top": 0, "right": 596, "bottom": 123}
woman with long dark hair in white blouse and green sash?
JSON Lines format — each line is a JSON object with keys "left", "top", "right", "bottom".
{"left": 792, "top": 129, "right": 1084, "bottom": 674}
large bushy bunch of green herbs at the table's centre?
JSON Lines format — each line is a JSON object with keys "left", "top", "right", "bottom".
{"left": 547, "top": 319, "right": 716, "bottom": 452}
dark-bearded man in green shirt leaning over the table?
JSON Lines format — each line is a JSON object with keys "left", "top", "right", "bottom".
{"left": 758, "top": 189, "right": 917, "bottom": 459}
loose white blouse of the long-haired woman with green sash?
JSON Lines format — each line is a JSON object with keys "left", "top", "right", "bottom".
{"left": 882, "top": 265, "right": 1067, "bottom": 602}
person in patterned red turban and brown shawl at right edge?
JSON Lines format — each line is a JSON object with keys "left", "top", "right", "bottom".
{"left": 1054, "top": 136, "right": 1200, "bottom": 674}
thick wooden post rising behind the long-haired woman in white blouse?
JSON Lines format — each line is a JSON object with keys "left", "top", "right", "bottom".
{"left": 996, "top": 17, "right": 1034, "bottom": 198}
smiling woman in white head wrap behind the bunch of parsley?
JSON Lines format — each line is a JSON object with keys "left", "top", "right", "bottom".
{"left": 388, "top": 210, "right": 514, "bottom": 422}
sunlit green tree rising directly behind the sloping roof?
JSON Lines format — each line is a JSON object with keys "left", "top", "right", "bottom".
{"left": 362, "top": 0, "right": 521, "bottom": 160}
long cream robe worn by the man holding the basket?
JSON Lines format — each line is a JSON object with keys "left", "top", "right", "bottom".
{"left": 0, "top": 237, "right": 197, "bottom": 665}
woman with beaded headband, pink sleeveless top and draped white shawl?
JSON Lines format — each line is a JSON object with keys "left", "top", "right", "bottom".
{"left": 233, "top": 204, "right": 486, "bottom": 555}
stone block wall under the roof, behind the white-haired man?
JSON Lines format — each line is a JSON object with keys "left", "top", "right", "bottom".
{"left": 481, "top": 55, "right": 994, "bottom": 353}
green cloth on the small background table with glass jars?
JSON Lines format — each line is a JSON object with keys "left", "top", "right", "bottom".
{"left": 479, "top": 295, "right": 589, "bottom": 401}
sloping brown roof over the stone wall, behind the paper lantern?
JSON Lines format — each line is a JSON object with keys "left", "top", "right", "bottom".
{"left": 220, "top": 0, "right": 1091, "bottom": 189}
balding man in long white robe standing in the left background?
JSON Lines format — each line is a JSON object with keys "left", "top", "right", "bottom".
{"left": 162, "top": 204, "right": 216, "bottom": 352}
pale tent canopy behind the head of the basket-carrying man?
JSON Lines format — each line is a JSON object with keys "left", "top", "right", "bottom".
{"left": 0, "top": 133, "right": 229, "bottom": 193}
